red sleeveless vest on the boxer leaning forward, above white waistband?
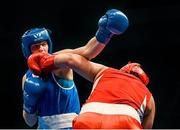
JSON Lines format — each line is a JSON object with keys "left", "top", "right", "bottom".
{"left": 86, "top": 68, "right": 152, "bottom": 111}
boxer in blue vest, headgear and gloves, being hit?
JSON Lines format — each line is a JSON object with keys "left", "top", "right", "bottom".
{"left": 22, "top": 9, "right": 129, "bottom": 129}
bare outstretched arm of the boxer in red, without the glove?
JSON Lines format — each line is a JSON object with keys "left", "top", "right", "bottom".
{"left": 54, "top": 53, "right": 107, "bottom": 82}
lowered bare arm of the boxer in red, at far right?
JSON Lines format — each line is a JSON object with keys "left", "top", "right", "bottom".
{"left": 142, "top": 96, "right": 155, "bottom": 129}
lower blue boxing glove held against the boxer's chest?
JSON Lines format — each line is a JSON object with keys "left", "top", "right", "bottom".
{"left": 23, "top": 77, "right": 46, "bottom": 114}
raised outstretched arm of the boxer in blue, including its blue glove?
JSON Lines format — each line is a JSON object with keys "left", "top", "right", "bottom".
{"left": 54, "top": 9, "right": 129, "bottom": 60}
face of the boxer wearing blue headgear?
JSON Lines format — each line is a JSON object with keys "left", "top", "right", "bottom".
{"left": 31, "top": 41, "right": 48, "bottom": 53}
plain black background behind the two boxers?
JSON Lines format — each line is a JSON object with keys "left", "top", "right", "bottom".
{"left": 0, "top": 0, "right": 180, "bottom": 129}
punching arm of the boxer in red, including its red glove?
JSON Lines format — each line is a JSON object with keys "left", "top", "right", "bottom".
{"left": 28, "top": 53, "right": 106, "bottom": 81}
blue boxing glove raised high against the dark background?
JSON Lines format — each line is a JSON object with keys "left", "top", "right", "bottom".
{"left": 96, "top": 9, "right": 129, "bottom": 44}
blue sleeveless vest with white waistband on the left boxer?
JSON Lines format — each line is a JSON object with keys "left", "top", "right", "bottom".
{"left": 26, "top": 70, "right": 80, "bottom": 129}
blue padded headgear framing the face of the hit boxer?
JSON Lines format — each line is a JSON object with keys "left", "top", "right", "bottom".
{"left": 22, "top": 28, "right": 52, "bottom": 58}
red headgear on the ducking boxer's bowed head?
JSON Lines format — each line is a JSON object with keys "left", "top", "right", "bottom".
{"left": 120, "top": 63, "right": 149, "bottom": 85}
